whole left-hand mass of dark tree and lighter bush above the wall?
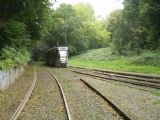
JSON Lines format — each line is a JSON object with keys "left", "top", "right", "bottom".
{"left": 0, "top": 0, "right": 52, "bottom": 69}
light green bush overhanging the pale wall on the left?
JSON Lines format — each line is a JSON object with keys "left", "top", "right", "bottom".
{"left": 0, "top": 47, "right": 30, "bottom": 69}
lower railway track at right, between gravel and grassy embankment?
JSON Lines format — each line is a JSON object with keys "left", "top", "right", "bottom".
{"left": 73, "top": 70, "right": 160, "bottom": 89}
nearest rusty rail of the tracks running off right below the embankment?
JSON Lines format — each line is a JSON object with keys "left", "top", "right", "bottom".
{"left": 73, "top": 71, "right": 160, "bottom": 89}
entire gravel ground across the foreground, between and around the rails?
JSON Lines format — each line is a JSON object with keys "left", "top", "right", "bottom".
{"left": 0, "top": 66, "right": 160, "bottom": 120}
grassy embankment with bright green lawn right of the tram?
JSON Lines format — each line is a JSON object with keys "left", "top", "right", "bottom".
{"left": 69, "top": 48, "right": 160, "bottom": 75}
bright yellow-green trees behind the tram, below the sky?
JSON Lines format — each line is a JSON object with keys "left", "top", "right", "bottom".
{"left": 47, "top": 3, "right": 110, "bottom": 55}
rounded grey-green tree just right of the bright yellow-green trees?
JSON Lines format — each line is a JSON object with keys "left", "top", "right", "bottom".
{"left": 106, "top": 10, "right": 132, "bottom": 54}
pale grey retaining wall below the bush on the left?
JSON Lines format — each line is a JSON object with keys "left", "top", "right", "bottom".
{"left": 0, "top": 66, "right": 24, "bottom": 90}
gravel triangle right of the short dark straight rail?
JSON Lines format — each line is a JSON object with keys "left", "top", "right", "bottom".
{"left": 77, "top": 75, "right": 160, "bottom": 120}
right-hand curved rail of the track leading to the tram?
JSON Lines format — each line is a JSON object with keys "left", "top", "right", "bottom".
{"left": 46, "top": 69, "right": 72, "bottom": 120}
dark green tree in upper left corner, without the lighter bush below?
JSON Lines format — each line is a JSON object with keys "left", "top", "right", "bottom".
{"left": 0, "top": 0, "right": 50, "bottom": 47}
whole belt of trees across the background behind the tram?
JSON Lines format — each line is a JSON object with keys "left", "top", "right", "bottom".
{"left": 0, "top": 0, "right": 160, "bottom": 69}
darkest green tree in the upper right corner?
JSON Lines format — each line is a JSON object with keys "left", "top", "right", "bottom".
{"left": 139, "top": 0, "right": 160, "bottom": 50}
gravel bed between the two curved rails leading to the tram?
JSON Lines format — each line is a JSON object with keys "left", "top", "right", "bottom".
{"left": 19, "top": 67, "right": 66, "bottom": 120}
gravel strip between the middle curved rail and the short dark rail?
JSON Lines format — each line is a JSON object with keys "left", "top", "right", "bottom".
{"left": 48, "top": 68, "right": 122, "bottom": 120}
